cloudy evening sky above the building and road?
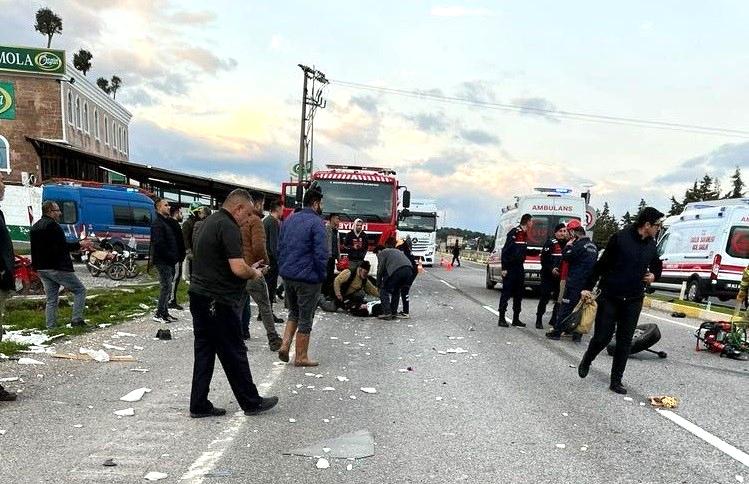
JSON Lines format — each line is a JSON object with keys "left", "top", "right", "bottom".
{"left": 0, "top": 0, "right": 749, "bottom": 233}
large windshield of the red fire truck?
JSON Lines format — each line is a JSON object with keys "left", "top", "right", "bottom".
{"left": 315, "top": 180, "right": 394, "bottom": 222}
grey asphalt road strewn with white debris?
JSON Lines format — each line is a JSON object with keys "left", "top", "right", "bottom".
{"left": 0, "top": 263, "right": 749, "bottom": 483}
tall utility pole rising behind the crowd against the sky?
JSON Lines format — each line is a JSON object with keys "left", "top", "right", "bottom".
{"left": 294, "top": 64, "right": 328, "bottom": 197}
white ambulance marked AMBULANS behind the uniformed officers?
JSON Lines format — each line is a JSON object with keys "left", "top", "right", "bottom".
{"left": 486, "top": 187, "right": 596, "bottom": 289}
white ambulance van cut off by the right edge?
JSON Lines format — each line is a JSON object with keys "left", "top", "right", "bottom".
{"left": 654, "top": 198, "right": 749, "bottom": 302}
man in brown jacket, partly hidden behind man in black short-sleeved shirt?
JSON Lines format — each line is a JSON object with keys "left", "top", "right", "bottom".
{"left": 240, "top": 193, "right": 281, "bottom": 351}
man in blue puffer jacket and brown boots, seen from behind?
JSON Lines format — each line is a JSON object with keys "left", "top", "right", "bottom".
{"left": 278, "top": 188, "right": 330, "bottom": 366}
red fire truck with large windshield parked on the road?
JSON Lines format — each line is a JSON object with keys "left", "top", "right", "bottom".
{"left": 281, "top": 165, "right": 411, "bottom": 267}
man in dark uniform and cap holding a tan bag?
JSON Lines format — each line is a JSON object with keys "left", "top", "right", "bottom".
{"left": 546, "top": 219, "right": 598, "bottom": 342}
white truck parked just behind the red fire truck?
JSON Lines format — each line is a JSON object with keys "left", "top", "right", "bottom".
{"left": 398, "top": 199, "right": 437, "bottom": 267}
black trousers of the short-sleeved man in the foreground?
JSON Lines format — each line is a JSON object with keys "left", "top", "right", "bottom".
{"left": 190, "top": 293, "right": 262, "bottom": 413}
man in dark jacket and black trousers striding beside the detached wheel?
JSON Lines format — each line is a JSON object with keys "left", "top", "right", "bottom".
{"left": 577, "top": 207, "right": 663, "bottom": 394}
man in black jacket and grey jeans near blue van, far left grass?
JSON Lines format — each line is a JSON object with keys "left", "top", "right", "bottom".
{"left": 29, "top": 200, "right": 86, "bottom": 328}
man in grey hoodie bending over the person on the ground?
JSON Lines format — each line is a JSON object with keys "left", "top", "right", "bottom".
{"left": 376, "top": 239, "right": 413, "bottom": 319}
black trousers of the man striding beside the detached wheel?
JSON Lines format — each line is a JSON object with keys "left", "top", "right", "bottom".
{"left": 583, "top": 294, "right": 643, "bottom": 384}
